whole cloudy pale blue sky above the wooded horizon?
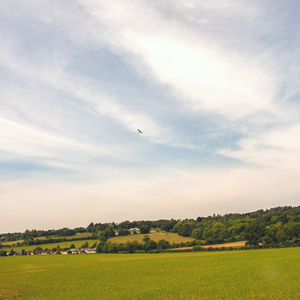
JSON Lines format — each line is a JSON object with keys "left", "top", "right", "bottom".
{"left": 0, "top": 0, "right": 300, "bottom": 233}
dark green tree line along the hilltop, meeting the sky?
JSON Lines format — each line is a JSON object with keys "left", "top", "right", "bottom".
{"left": 0, "top": 206, "right": 300, "bottom": 246}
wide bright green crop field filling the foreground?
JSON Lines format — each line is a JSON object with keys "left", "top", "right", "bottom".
{"left": 0, "top": 248, "right": 300, "bottom": 299}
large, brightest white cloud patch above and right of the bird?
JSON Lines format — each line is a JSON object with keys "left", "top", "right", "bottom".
{"left": 78, "top": 1, "right": 282, "bottom": 120}
